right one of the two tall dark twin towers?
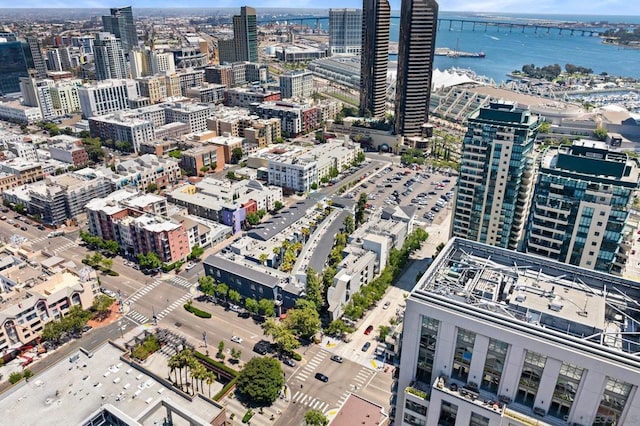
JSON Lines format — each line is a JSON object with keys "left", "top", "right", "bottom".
{"left": 395, "top": 0, "right": 438, "bottom": 136}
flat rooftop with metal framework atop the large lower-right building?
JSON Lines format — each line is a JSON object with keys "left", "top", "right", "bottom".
{"left": 412, "top": 238, "right": 640, "bottom": 358}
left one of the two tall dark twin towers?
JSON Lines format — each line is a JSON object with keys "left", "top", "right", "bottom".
{"left": 360, "top": 0, "right": 391, "bottom": 117}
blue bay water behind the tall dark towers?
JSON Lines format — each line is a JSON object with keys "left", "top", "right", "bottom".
{"left": 302, "top": 12, "right": 640, "bottom": 82}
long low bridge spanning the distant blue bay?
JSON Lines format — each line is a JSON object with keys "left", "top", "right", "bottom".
{"left": 258, "top": 16, "right": 602, "bottom": 36}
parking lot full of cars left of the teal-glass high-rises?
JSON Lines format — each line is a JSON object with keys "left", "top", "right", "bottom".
{"left": 354, "top": 165, "right": 456, "bottom": 222}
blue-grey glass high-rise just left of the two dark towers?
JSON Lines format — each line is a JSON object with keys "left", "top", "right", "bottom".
{"left": 329, "top": 9, "right": 362, "bottom": 55}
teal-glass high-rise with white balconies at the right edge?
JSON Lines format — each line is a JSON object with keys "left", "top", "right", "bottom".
{"left": 524, "top": 140, "right": 639, "bottom": 274}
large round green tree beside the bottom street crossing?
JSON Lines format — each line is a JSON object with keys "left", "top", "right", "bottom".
{"left": 237, "top": 357, "right": 284, "bottom": 406}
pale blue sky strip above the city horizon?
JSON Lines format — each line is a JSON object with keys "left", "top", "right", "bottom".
{"left": 8, "top": 0, "right": 640, "bottom": 16}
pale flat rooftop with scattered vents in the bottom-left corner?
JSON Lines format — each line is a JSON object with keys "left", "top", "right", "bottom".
{"left": 0, "top": 343, "right": 220, "bottom": 426}
